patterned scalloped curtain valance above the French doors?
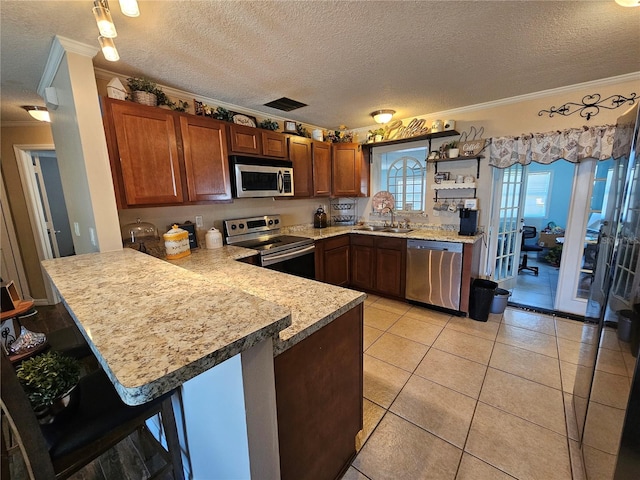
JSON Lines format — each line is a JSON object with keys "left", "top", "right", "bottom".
{"left": 489, "top": 125, "right": 616, "bottom": 168}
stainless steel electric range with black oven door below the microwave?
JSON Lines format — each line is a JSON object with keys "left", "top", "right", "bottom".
{"left": 223, "top": 215, "right": 315, "bottom": 279}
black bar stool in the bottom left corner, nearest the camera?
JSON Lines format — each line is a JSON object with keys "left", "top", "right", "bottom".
{"left": 1, "top": 352, "right": 184, "bottom": 480}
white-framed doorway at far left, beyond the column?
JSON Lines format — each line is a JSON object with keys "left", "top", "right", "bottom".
{"left": 14, "top": 145, "right": 75, "bottom": 304}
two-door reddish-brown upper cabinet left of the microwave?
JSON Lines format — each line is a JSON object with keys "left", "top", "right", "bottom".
{"left": 104, "top": 98, "right": 231, "bottom": 208}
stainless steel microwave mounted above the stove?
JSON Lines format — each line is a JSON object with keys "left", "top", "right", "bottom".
{"left": 229, "top": 155, "right": 293, "bottom": 198}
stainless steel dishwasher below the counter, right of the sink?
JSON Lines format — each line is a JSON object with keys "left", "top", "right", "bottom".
{"left": 405, "top": 239, "right": 462, "bottom": 310}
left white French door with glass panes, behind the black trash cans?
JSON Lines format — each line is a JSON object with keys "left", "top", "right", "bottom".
{"left": 488, "top": 164, "right": 526, "bottom": 289}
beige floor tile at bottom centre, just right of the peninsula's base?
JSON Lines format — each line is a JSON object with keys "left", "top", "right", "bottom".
{"left": 353, "top": 413, "right": 462, "bottom": 480}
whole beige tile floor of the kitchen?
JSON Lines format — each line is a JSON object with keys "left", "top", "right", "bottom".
{"left": 343, "top": 296, "right": 583, "bottom": 480}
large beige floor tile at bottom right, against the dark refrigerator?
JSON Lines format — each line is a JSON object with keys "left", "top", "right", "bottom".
{"left": 465, "top": 402, "right": 571, "bottom": 480}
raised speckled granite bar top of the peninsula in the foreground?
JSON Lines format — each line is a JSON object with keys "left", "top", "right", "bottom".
{"left": 42, "top": 248, "right": 291, "bottom": 405}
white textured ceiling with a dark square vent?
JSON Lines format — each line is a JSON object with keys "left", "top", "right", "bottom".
{"left": 0, "top": 0, "right": 640, "bottom": 128}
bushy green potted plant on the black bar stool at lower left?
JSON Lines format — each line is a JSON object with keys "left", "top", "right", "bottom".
{"left": 16, "top": 351, "right": 80, "bottom": 424}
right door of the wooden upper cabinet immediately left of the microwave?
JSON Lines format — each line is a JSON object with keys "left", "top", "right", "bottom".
{"left": 180, "top": 115, "right": 231, "bottom": 202}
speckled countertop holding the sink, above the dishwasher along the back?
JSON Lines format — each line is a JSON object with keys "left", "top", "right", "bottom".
{"left": 282, "top": 225, "right": 483, "bottom": 243}
